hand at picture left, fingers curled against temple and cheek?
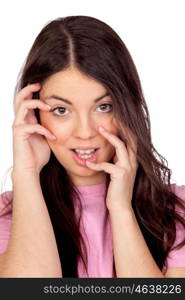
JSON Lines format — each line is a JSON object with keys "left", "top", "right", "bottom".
{"left": 12, "top": 84, "right": 55, "bottom": 174}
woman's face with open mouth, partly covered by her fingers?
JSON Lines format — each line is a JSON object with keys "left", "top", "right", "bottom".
{"left": 40, "top": 68, "right": 118, "bottom": 186}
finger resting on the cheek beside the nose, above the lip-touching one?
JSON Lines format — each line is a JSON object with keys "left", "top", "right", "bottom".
{"left": 99, "top": 127, "right": 129, "bottom": 166}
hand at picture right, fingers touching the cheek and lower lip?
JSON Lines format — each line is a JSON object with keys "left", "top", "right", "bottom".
{"left": 87, "top": 128, "right": 138, "bottom": 211}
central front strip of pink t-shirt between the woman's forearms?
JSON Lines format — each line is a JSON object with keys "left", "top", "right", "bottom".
{"left": 76, "top": 183, "right": 116, "bottom": 278}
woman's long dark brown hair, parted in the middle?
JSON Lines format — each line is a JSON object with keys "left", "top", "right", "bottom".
{"left": 0, "top": 16, "right": 185, "bottom": 277}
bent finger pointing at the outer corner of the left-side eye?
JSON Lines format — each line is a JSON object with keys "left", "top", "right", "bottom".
{"left": 14, "top": 100, "right": 51, "bottom": 125}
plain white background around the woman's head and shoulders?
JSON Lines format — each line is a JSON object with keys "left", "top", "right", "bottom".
{"left": 0, "top": 0, "right": 185, "bottom": 190}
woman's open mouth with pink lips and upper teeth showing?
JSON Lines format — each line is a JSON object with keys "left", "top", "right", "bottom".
{"left": 71, "top": 148, "right": 100, "bottom": 166}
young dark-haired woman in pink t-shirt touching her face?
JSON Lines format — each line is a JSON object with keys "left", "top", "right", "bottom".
{"left": 0, "top": 16, "right": 185, "bottom": 277}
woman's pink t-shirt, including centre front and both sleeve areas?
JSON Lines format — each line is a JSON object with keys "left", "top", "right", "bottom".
{"left": 0, "top": 183, "right": 185, "bottom": 278}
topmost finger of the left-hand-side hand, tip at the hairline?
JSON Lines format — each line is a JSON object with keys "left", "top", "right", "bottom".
{"left": 14, "top": 83, "right": 41, "bottom": 112}
